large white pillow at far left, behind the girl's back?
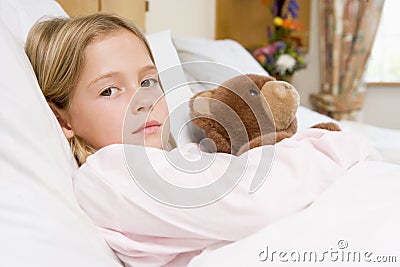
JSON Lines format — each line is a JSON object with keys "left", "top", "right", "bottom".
{"left": 0, "top": 17, "right": 121, "bottom": 267}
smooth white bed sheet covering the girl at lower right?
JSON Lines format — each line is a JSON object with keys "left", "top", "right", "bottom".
{"left": 189, "top": 162, "right": 400, "bottom": 267}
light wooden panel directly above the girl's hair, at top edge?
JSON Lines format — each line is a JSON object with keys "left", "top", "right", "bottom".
{"left": 57, "top": 0, "right": 146, "bottom": 31}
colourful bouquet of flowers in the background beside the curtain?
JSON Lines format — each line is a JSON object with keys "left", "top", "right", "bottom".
{"left": 253, "top": 0, "right": 306, "bottom": 81}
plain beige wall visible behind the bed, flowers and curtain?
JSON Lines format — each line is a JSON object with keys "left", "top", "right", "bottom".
{"left": 146, "top": 0, "right": 400, "bottom": 129}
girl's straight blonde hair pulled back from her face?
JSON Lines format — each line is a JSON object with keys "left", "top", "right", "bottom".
{"left": 25, "top": 13, "right": 154, "bottom": 165}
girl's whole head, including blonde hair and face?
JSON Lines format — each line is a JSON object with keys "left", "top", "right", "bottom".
{"left": 26, "top": 14, "right": 169, "bottom": 164}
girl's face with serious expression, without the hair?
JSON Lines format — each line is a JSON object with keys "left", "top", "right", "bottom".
{"left": 63, "top": 30, "right": 169, "bottom": 149}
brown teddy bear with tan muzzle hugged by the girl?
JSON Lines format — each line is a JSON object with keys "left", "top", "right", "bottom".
{"left": 189, "top": 74, "right": 340, "bottom": 155}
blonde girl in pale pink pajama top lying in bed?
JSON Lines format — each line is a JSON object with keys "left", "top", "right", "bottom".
{"left": 26, "top": 14, "right": 374, "bottom": 266}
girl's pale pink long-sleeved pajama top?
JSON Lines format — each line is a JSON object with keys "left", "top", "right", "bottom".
{"left": 74, "top": 129, "right": 379, "bottom": 266}
